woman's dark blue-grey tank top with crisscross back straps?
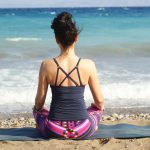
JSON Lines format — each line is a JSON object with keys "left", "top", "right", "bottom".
{"left": 48, "top": 58, "right": 88, "bottom": 121}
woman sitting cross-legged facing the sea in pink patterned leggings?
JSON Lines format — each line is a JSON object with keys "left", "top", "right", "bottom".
{"left": 33, "top": 12, "right": 104, "bottom": 139}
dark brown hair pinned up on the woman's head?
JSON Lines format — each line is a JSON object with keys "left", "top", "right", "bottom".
{"left": 51, "top": 12, "right": 80, "bottom": 48}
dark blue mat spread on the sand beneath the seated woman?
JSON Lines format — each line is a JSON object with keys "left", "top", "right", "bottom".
{"left": 0, "top": 124, "right": 150, "bottom": 141}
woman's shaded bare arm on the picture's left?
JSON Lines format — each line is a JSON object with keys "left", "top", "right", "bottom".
{"left": 34, "top": 61, "right": 48, "bottom": 110}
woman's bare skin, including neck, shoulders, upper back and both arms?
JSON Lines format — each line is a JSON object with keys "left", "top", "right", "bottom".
{"left": 35, "top": 38, "right": 104, "bottom": 110}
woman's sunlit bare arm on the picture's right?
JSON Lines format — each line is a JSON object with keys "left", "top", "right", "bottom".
{"left": 88, "top": 61, "right": 104, "bottom": 110}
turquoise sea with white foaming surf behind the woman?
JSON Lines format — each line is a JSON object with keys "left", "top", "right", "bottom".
{"left": 0, "top": 7, "right": 150, "bottom": 113}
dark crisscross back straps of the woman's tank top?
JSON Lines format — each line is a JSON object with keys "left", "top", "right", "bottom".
{"left": 53, "top": 58, "right": 82, "bottom": 86}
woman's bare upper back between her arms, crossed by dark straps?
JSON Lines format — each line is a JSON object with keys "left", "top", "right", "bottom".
{"left": 45, "top": 56, "right": 90, "bottom": 86}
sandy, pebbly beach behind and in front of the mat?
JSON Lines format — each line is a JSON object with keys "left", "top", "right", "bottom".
{"left": 0, "top": 113, "right": 150, "bottom": 150}
